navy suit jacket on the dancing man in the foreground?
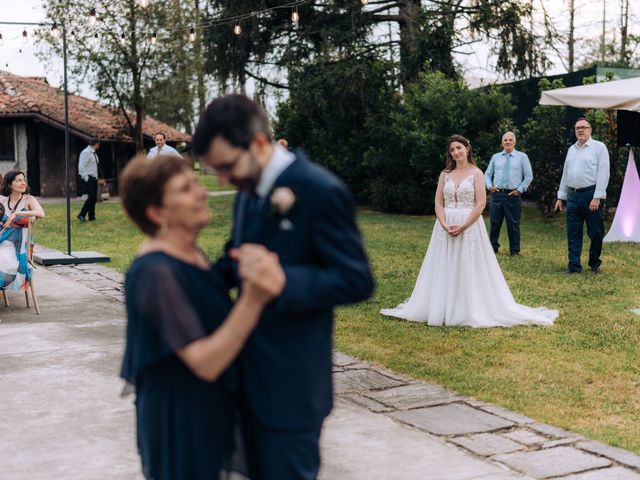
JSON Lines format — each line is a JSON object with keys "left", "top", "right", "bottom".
{"left": 216, "top": 152, "right": 374, "bottom": 429}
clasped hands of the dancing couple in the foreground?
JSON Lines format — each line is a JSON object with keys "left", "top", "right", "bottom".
{"left": 229, "top": 243, "right": 286, "bottom": 303}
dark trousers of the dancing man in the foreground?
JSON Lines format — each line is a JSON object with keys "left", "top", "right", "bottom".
{"left": 241, "top": 408, "right": 322, "bottom": 480}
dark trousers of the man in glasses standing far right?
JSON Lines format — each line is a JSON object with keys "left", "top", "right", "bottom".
{"left": 567, "top": 187, "right": 604, "bottom": 272}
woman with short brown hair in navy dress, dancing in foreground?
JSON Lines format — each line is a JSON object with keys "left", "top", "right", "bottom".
{"left": 121, "top": 156, "right": 284, "bottom": 480}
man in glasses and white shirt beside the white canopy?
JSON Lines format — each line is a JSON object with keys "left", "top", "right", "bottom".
{"left": 556, "top": 118, "right": 609, "bottom": 273}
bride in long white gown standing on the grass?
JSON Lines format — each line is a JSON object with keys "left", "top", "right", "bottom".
{"left": 380, "top": 135, "right": 558, "bottom": 327}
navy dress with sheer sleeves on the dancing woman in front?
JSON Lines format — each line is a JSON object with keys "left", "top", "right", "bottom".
{"left": 121, "top": 252, "right": 236, "bottom": 480}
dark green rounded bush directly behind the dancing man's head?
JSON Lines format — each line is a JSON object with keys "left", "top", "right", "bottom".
{"left": 276, "top": 58, "right": 398, "bottom": 202}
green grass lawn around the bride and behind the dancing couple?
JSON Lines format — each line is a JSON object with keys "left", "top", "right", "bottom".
{"left": 37, "top": 196, "right": 640, "bottom": 453}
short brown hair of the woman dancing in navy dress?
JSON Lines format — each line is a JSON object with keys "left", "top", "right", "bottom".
{"left": 120, "top": 155, "right": 191, "bottom": 236}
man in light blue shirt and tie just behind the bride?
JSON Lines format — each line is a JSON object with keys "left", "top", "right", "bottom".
{"left": 484, "top": 132, "right": 533, "bottom": 256}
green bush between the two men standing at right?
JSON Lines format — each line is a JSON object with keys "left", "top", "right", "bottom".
{"left": 521, "top": 78, "right": 572, "bottom": 216}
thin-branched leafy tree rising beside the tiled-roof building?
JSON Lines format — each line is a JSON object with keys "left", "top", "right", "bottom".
{"left": 42, "top": 0, "right": 199, "bottom": 150}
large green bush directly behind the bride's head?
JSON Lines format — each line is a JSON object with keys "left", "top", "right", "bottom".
{"left": 366, "top": 73, "right": 512, "bottom": 213}
